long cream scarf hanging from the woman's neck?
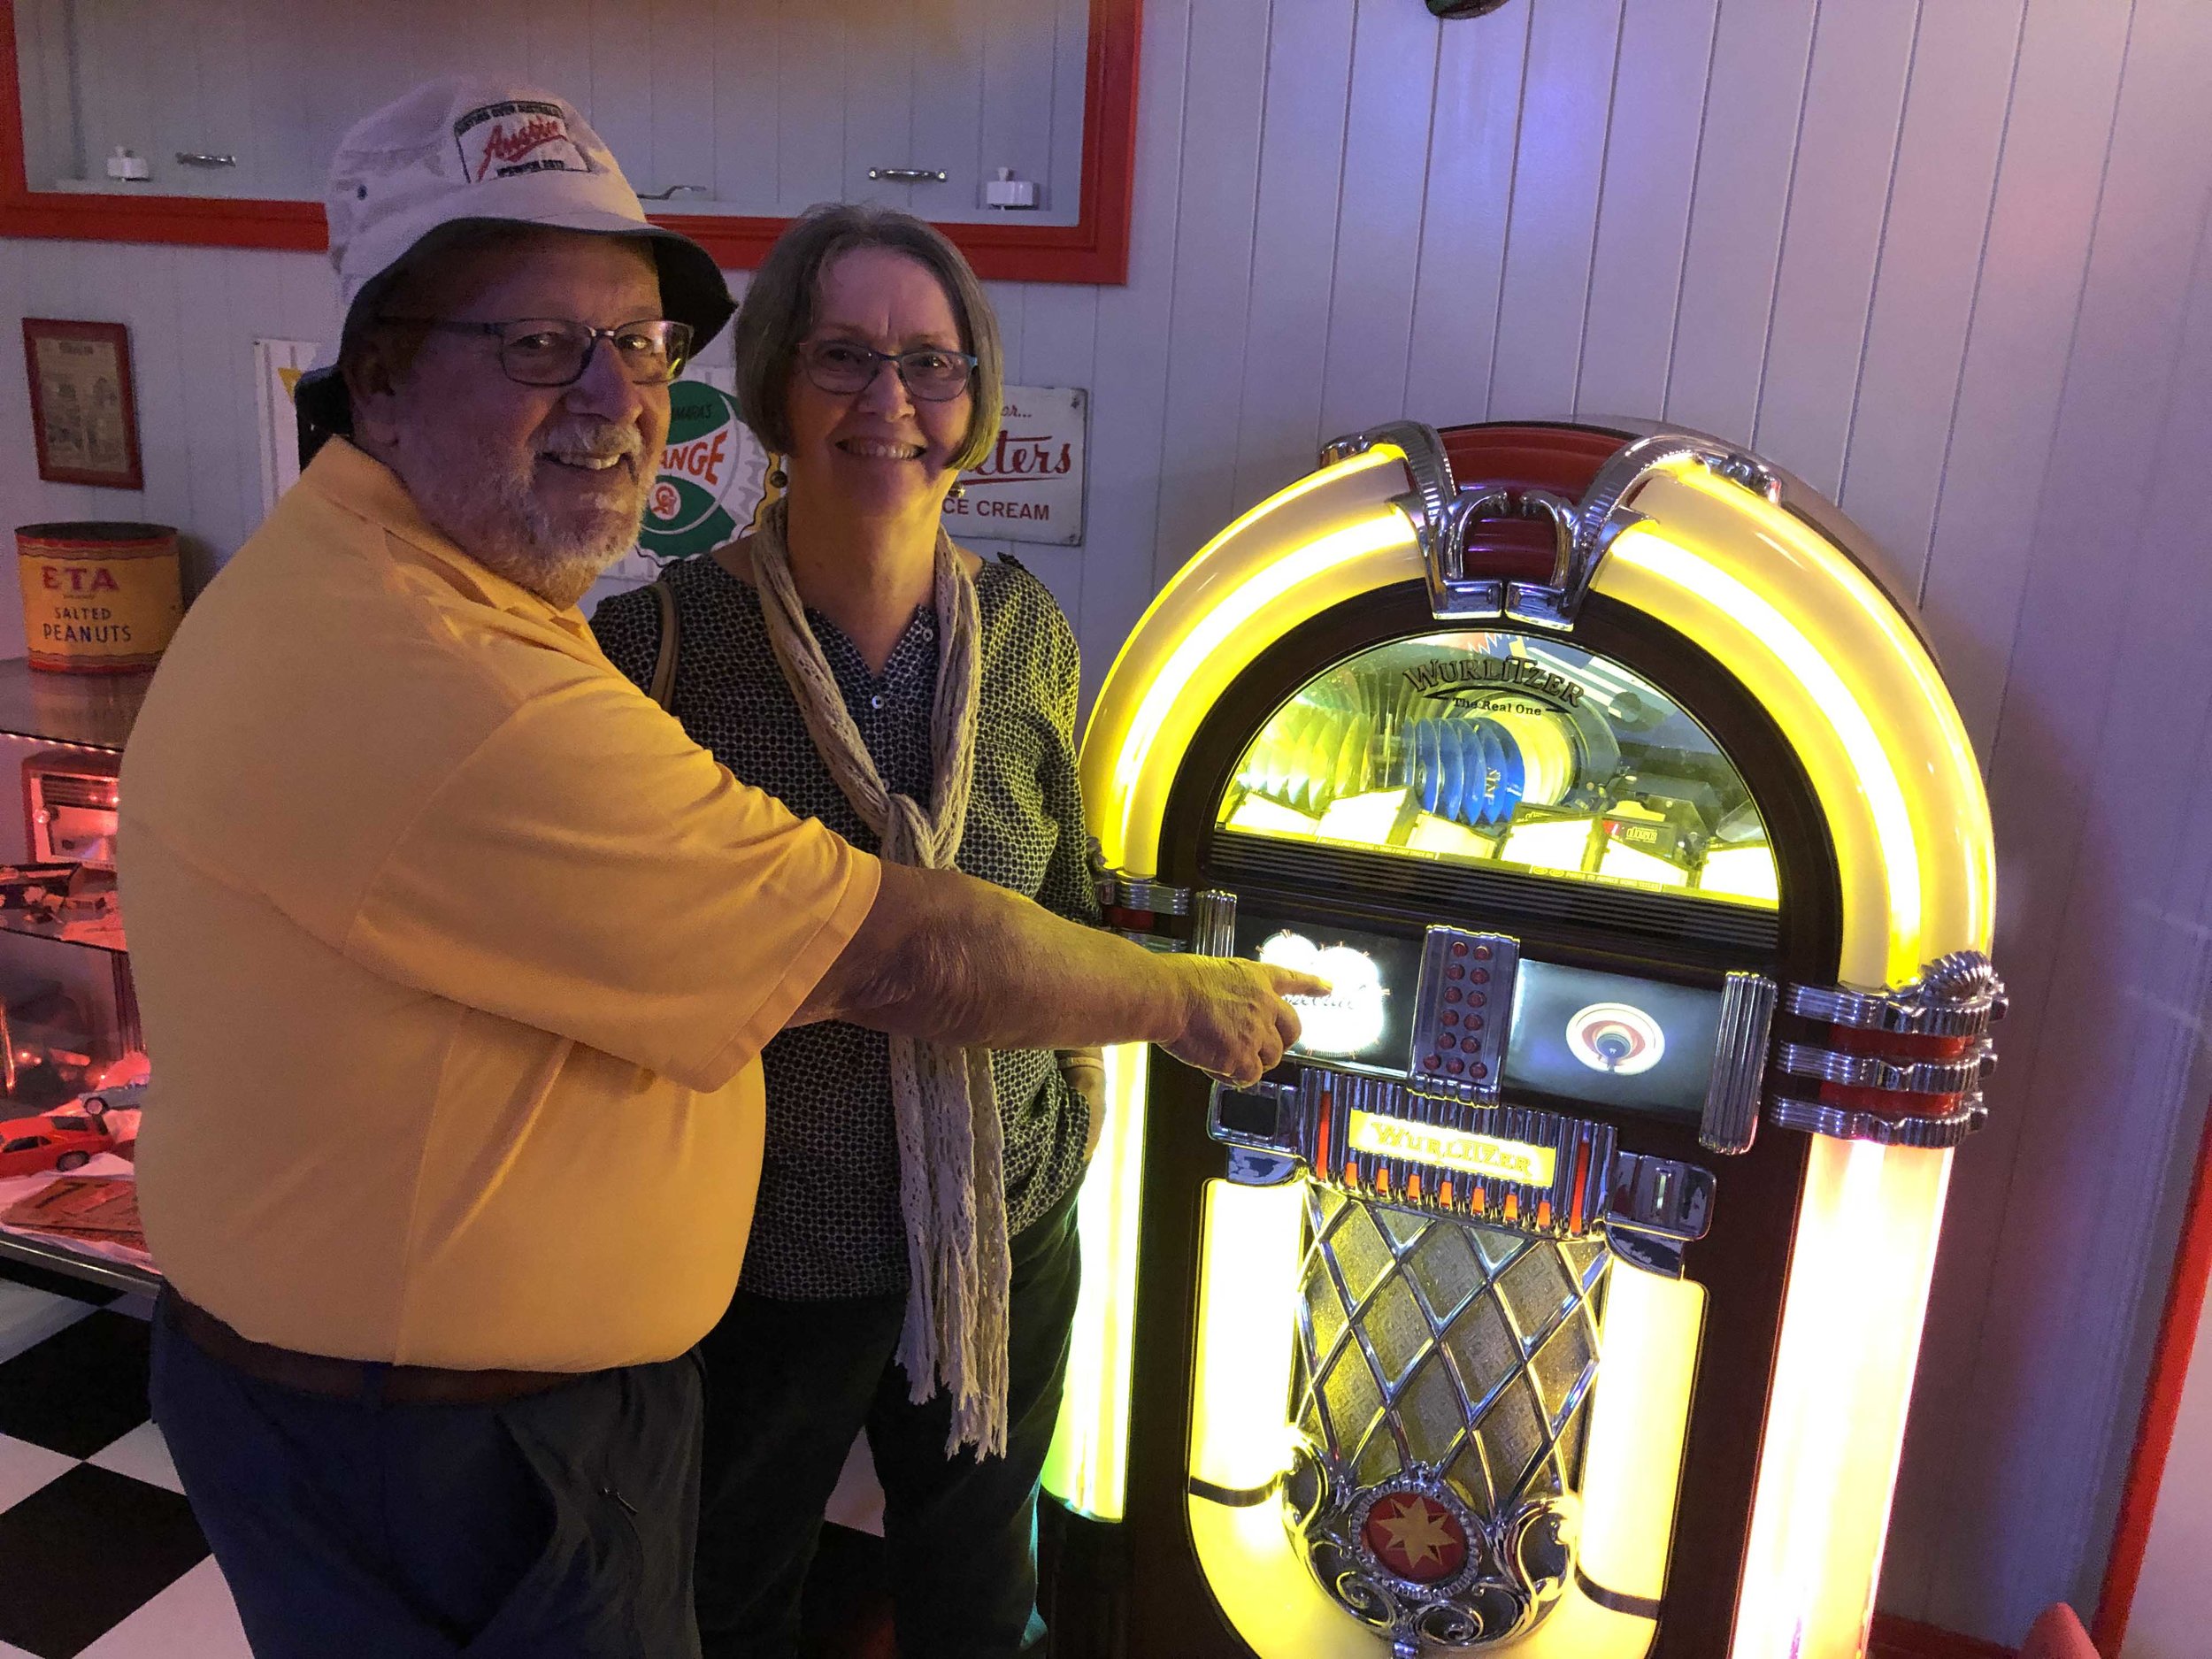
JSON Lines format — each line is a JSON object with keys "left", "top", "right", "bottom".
{"left": 752, "top": 503, "right": 1009, "bottom": 1455}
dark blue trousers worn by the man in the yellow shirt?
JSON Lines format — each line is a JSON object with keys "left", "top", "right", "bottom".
{"left": 153, "top": 1296, "right": 699, "bottom": 1659}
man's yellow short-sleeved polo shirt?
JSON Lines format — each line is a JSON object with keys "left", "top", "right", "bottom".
{"left": 122, "top": 441, "right": 879, "bottom": 1371}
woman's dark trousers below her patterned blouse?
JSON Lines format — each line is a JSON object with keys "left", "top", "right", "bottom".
{"left": 697, "top": 1193, "right": 1082, "bottom": 1659}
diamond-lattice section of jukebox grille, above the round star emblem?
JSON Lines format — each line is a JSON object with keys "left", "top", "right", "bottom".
{"left": 1294, "top": 1184, "right": 1610, "bottom": 1516}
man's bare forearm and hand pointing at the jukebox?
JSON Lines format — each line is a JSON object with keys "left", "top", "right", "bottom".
{"left": 792, "top": 863, "right": 1327, "bottom": 1084}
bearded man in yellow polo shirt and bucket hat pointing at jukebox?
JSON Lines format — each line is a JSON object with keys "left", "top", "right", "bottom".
{"left": 122, "top": 82, "right": 1314, "bottom": 1659}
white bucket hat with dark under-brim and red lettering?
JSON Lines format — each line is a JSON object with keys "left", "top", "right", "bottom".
{"left": 299, "top": 75, "right": 737, "bottom": 449}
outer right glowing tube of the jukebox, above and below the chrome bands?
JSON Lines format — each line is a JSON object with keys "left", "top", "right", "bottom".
{"left": 1593, "top": 465, "right": 1995, "bottom": 1659}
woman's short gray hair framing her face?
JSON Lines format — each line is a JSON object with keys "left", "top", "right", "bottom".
{"left": 733, "top": 202, "right": 1007, "bottom": 472}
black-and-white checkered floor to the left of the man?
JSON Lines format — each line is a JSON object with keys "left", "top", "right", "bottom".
{"left": 0, "top": 1261, "right": 250, "bottom": 1659}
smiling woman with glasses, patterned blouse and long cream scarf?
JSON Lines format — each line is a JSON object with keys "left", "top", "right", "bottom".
{"left": 593, "top": 206, "right": 1100, "bottom": 1659}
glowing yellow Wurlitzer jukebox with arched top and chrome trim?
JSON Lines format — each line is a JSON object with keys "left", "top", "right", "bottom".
{"left": 1047, "top": 425, "right": 2002, "bottom": 1659}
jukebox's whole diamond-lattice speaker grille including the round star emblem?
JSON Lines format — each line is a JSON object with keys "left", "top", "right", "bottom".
{"left": 1286, "top": 1181, "right": 1613, "bottom": 1653}
